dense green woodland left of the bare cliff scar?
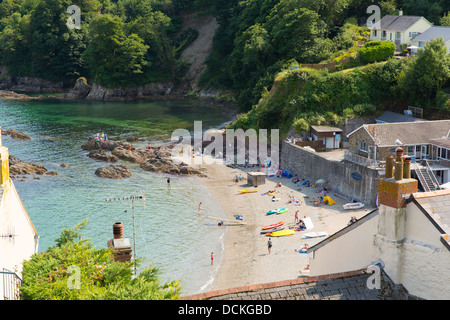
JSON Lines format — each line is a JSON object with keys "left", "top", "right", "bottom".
{"left": 0, "top": 0, "right": 191, "bottom": 87}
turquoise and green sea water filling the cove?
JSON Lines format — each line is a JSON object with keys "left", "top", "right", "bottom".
{"left": 0, "top": 100, "right": 234, "bottom": 295}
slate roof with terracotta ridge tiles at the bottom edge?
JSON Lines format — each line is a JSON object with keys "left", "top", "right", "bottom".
{"left": 181, "top": 270, "right": 416, "bottom": 300}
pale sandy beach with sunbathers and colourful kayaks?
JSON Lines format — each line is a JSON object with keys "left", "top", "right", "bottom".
{"left": 193, "top": 164, "right": 371, "bottom": 290}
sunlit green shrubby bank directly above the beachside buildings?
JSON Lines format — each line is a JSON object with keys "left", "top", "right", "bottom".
{"left": 234, "top": 38, "right": 450, "bottom": 135}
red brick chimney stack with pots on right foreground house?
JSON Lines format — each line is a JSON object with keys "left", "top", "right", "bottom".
{"left": 378, "top": 147, "right": 418, "bottom": 209}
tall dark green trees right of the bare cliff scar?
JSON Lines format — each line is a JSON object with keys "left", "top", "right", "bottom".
{"left": 196, "top": 0, "right": 450, "bottom": 112}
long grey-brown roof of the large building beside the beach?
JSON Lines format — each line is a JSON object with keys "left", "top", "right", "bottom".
{"left": 348, "top": 120, "right": 450, "bottom": 147}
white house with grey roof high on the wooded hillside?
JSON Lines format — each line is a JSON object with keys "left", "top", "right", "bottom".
{"left": 369, "top": 11, "right": 433, "bottom": 48}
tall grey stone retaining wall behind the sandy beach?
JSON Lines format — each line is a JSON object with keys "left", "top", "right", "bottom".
{"left": 281, "top": 141, "right": 379, "bottom": 206}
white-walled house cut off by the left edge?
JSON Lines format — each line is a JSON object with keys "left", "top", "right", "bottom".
{"left": 0, "top": 131, "right": 39, "bottom": 300}
